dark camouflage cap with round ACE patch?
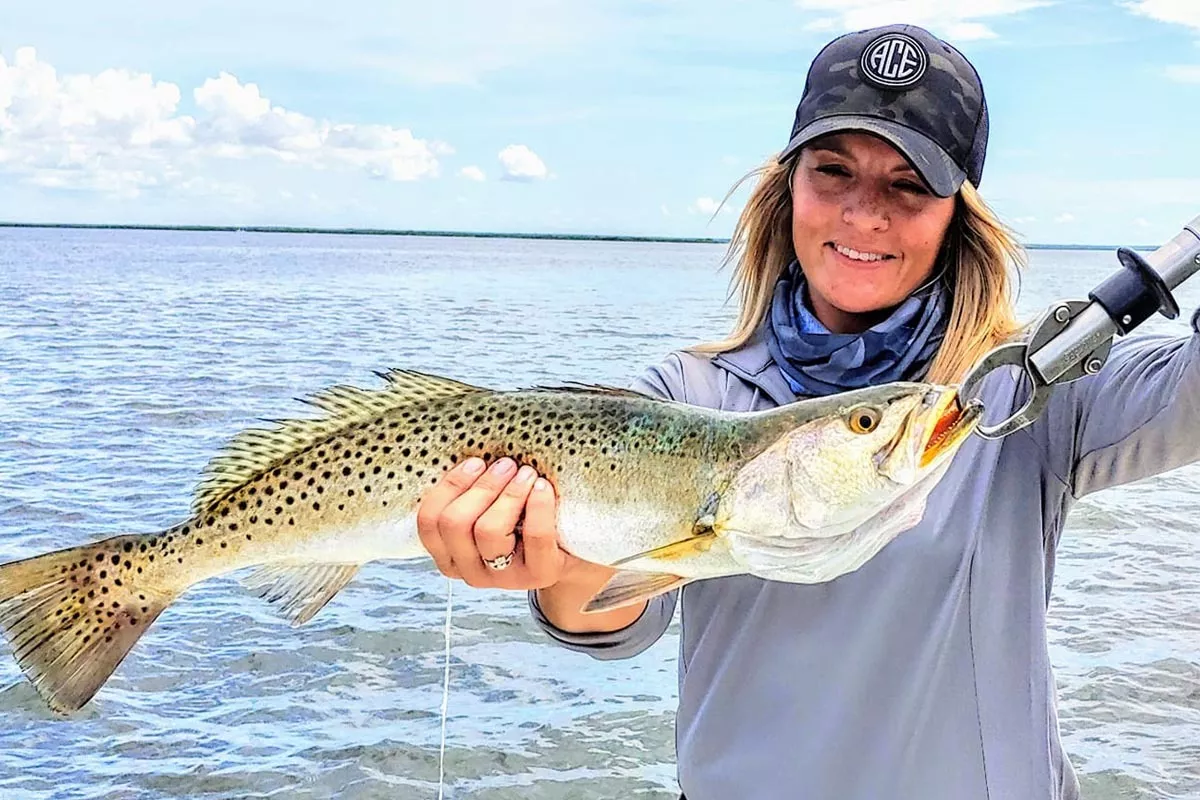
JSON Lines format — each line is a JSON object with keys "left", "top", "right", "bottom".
{"left": 780, "top": 25, "right": 988, "bottom": 197}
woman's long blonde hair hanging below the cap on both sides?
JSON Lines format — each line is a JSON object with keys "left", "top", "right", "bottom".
{"left": 689, "top": 158, "right": 1026, "bottom": 384}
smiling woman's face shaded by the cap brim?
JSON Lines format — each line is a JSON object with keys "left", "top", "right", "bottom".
{"left": 792, "top": 132, "right": 954, "bottom": 333}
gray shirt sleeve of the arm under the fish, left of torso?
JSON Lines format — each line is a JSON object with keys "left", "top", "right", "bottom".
{"left": 529, "top": 355, "right": 683, "bottom": 661}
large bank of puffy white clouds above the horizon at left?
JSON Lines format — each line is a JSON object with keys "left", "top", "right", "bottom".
{"left": 0, "top": 47, "right": 452, "bottom": 197}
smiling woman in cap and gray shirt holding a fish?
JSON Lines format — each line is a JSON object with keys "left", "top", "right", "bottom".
{"left": 418, "top": 21, "right": 1200, "bottom": 800}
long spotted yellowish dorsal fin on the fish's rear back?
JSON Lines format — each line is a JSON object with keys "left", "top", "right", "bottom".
{"left": 192, "top": 369, "right": 488, "bottom": 513}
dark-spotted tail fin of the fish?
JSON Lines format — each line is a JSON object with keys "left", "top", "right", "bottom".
{"left": 0, "top": 535, "right": 180, "bottom": 714}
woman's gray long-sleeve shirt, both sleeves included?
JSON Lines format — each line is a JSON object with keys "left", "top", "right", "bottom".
{"left": 530, "top": 309, "right": 1200, "bottom": 800}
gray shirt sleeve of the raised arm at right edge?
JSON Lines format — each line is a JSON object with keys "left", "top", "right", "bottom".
{"left": 1048, "top": 311, "right": 1200, "bottom": 498}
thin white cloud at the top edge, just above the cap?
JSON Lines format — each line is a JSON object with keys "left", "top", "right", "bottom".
{"left": 796, "top": 0, "right": 1051, "bottom": 42}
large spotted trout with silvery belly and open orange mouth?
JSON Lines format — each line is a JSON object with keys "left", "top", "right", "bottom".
{"left": 0, "top": 369, "right": 980, "bottom": 715}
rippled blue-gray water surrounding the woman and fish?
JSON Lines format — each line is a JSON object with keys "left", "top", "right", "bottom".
{"left": 0, "top": 229, "right": 1200, "bottom": 800}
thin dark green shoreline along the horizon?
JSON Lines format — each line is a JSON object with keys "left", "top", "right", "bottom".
{"left": 0, "top": 222, "right": 1156, "bottom": 251}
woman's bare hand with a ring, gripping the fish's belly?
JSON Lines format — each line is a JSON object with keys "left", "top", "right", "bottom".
{"left": 416, "top": 458, "right": 582, "bottom": 589}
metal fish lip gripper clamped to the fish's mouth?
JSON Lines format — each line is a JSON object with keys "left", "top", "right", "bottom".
{"left": 961, "top": 216, "right": 1200, "bottom": 439}
